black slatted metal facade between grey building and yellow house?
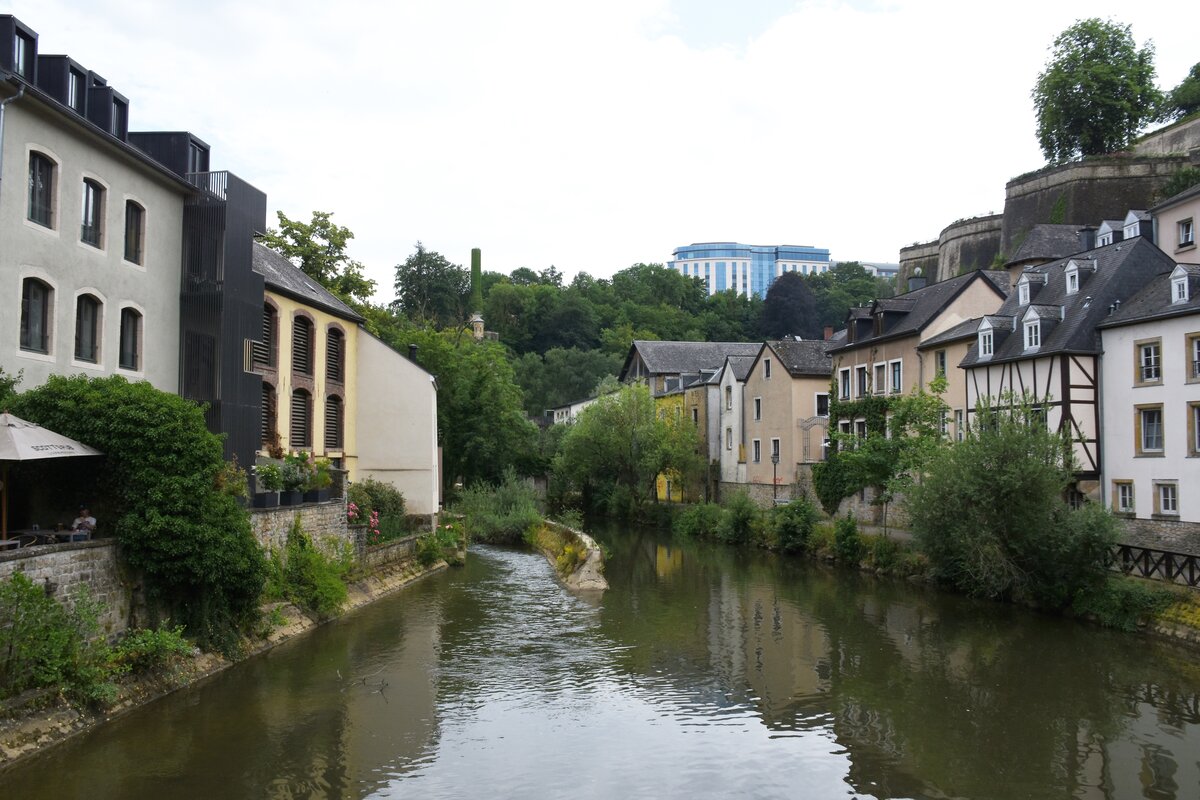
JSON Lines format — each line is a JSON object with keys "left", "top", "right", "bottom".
{"left": 180, "top": 173, "right": 266, "bottom": 465}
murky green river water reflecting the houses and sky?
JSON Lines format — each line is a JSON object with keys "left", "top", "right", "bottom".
{"left": 0, "top": 531, "right": 1200, "bottom": 800}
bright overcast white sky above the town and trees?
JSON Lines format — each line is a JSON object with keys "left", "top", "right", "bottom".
{"left": 11, "top": 0, "right": 1200, "bottom": 300}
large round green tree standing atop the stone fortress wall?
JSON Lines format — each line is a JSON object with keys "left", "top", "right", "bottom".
{"left": 1033, "top": 18, "right": 1162, "bottom": 163}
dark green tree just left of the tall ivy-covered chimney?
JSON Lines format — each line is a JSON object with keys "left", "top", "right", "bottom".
{"left": 392, "top": 242, "right": 470, "bottom": 329}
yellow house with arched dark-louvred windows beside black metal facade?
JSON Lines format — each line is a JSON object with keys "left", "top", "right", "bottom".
{"left": 252, "top": 242, "right": 362, "bottom": 481}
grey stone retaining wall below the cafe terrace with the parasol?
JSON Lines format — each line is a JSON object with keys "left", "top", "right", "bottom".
{"left": 0, "top": 539, "right": 133, "bottom": 638}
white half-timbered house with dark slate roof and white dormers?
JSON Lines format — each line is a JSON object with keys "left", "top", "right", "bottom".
{"left": 960, "top": 237, "right": 1175, "bottom": 500}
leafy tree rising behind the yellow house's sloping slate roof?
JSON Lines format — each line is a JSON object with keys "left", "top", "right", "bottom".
{"left": 262, "top": 211, "right": 376, "bottom": 303}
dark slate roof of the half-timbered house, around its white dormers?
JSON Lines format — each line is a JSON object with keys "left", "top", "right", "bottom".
{"left": 961, "top": 236, "right": 1175, "bottom": 367}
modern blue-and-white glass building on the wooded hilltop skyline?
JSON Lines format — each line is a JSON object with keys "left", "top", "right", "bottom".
{"left": 667, "top": 241, "right": 832, "bottom": 297}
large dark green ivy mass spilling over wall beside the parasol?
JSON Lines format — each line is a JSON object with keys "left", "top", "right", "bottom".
{"left": 12, "top": 375, "right": 266, "bottom": 651}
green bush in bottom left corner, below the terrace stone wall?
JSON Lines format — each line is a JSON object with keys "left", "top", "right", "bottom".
{"left": 0, "top": 572, "right": 116, "bottom": 704}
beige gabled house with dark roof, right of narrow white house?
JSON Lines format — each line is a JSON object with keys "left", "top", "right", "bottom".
{"left": 743, "top": 339, "right": 830, "bottom": 497}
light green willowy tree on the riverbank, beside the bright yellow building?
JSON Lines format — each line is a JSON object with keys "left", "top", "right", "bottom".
{"left": 554, "top": 385, "right": 703, "bottom": 511}
